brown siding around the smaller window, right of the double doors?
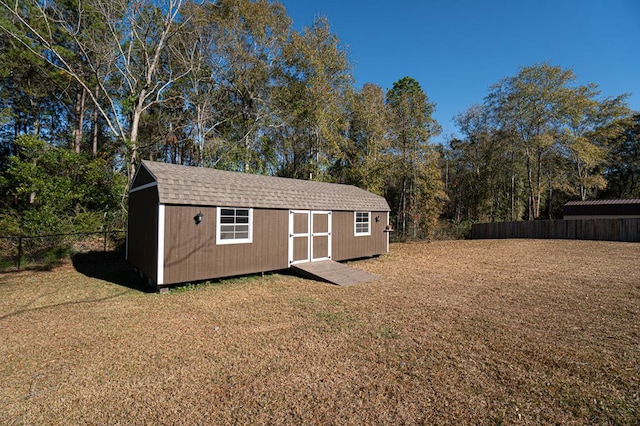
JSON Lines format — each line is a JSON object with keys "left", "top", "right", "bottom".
{"left": 331, "top": 211, "right": 388, "bottom": 261}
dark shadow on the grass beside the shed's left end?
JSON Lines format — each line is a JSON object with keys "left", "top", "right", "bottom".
{"left": 72, "top": 251, "right": 155, "bottom": 293}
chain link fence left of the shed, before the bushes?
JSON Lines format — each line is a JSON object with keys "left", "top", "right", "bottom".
{"left": 0, "top": 229, "right": 126, "bottom": 271}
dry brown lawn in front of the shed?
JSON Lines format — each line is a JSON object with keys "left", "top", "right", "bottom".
{"left": 0, "top": 240, "right": 640, "bottom": 425}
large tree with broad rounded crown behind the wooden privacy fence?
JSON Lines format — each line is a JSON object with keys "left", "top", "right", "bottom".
{"left": 486, "top": 64, "right": 628, "bottom": 220}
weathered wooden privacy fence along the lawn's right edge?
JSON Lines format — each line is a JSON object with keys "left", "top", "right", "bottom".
{"left": 471, "top": 219, "right": 640, "bottom": 242}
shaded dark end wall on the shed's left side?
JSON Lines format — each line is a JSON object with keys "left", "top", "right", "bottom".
{"left": 127, "top": 187, "right": 158, "bottom": 282}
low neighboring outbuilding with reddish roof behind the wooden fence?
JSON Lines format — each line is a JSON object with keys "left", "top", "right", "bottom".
{"left": 563, "top": 198, "right": 640, "bottom": 220}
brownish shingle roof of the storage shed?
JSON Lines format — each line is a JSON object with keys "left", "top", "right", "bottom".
{"left": 134, "top": 161, "right": 389, "bottom": 211}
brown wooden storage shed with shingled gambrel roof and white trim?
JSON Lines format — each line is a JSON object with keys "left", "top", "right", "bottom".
{"left": 126, "top": 161, "right": 390, "bottom": 288}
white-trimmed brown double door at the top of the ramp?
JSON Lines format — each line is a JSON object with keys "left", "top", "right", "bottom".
{"left": 289, "top": 210, "right": 331, "bottom": 265}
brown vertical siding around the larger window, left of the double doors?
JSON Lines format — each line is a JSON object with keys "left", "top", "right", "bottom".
{"left": 164, "top": 205, "right": 289, "bottom": 284}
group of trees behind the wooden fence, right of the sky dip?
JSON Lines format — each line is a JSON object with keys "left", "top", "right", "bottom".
{"left": 440, "top": 63, "right": 640, "bottom": 223}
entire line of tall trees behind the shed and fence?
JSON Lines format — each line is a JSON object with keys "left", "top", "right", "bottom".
{"left": 0, "top": 0, "right": 638, "bottom": 238}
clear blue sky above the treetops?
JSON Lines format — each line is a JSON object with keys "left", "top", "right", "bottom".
{"left": 281, "top": 0, "right": 640, "bottom": 142}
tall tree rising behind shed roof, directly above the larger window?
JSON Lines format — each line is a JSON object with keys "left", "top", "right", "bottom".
{"left": 196, "top": 0, "right": 291, "bottom": 173}
